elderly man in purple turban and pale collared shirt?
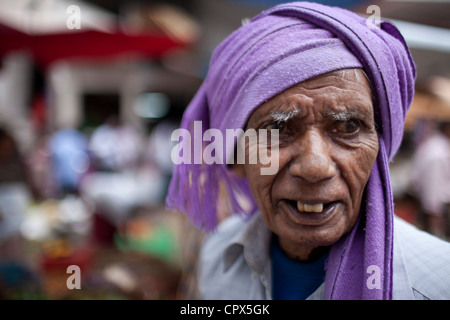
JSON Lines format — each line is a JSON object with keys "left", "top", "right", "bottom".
{"left": 167, "top": 2, "right": 450, "bottom": 299}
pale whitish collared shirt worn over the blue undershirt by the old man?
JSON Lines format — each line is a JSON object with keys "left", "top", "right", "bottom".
{"left": 198, "top": 214, "right": 450, "bottom": 300}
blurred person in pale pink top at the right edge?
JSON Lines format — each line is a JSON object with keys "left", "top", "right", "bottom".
{"left": 410, "top": 121, "right": 450, "bottom": 239}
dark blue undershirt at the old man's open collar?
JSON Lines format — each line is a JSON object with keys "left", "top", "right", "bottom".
{"left": 270, "top": 237, "right": 328, "bottom": 300}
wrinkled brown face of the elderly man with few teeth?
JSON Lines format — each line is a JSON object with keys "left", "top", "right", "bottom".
{"left": 236, "top": 69, "right": 378, "bottom": 260}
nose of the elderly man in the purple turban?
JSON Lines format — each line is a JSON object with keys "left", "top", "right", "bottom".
{"left": 289, "top": 129, "right": 337, "bottom": 183}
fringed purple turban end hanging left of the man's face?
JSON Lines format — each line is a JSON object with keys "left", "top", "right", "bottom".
{"left": 166, "top": 85, "right": 257, "bottom": 232}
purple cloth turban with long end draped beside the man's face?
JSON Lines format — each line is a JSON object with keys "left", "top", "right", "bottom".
{"left": 166, "top": 2, "right": 416, "bottom": 299}
